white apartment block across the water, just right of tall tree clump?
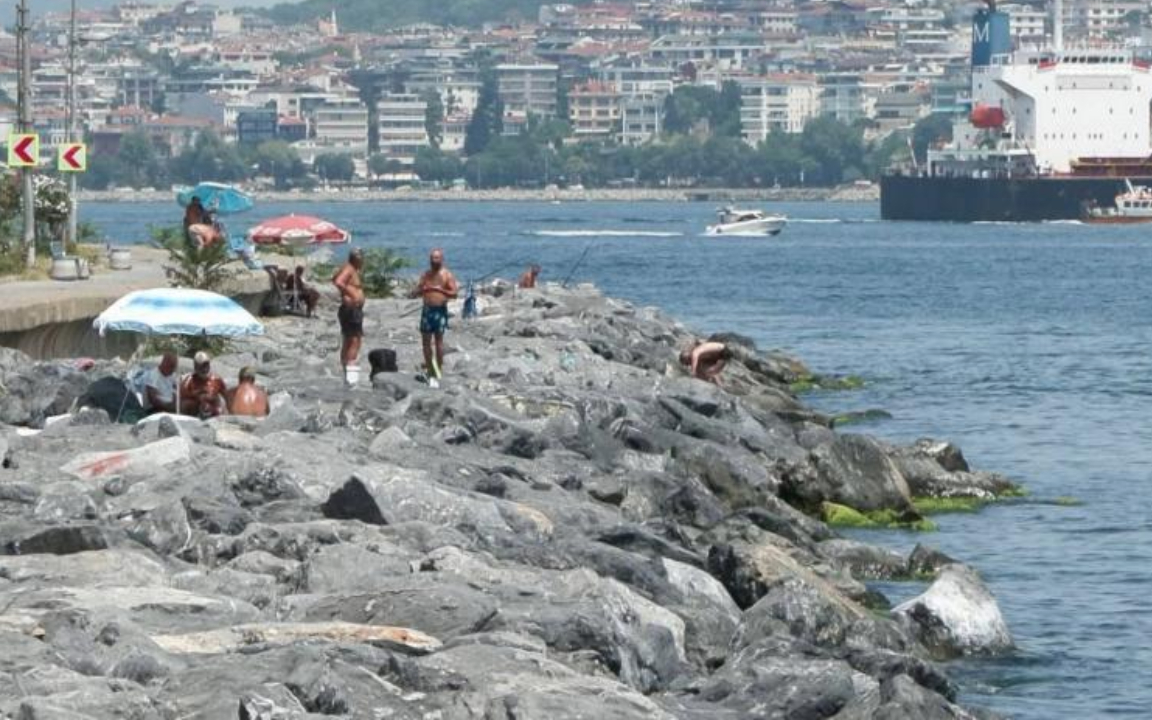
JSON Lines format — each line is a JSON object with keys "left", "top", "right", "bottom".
{"left": 740, "top": 74, "right": 820, "bottom": 145}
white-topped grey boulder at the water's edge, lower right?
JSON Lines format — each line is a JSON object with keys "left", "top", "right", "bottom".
{"left": 892, "top": 564, "right": 1015, "bottom": 658}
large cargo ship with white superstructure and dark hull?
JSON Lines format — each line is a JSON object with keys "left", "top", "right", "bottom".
{"left": 880, "top": 0, "right": 1152, "bottom": 222}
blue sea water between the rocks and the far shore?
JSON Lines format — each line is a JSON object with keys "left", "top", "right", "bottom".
{"left": 81, "top": 203, "right": 1152, "bottom": 720}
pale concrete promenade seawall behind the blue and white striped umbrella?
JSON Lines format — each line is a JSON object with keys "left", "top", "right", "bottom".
{"left": 0, "top": 247, "right": 278, "bottom": 359}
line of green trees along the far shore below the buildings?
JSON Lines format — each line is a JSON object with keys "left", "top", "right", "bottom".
{"left": 81, "top": 77, "right": 950, "bottom": 190}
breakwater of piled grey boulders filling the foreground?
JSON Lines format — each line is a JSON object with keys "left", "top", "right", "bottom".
{"left": 0, "top": 287, "right": 1027, "bottom": 720}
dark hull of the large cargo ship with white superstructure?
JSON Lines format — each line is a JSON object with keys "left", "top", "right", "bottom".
{"left": 880, "top": 175, "right": 1133, "bottom": 222}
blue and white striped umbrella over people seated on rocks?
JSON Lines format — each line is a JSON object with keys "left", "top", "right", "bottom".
{"left": 92, "top": 288, "right": 264, "bottom": 338}
